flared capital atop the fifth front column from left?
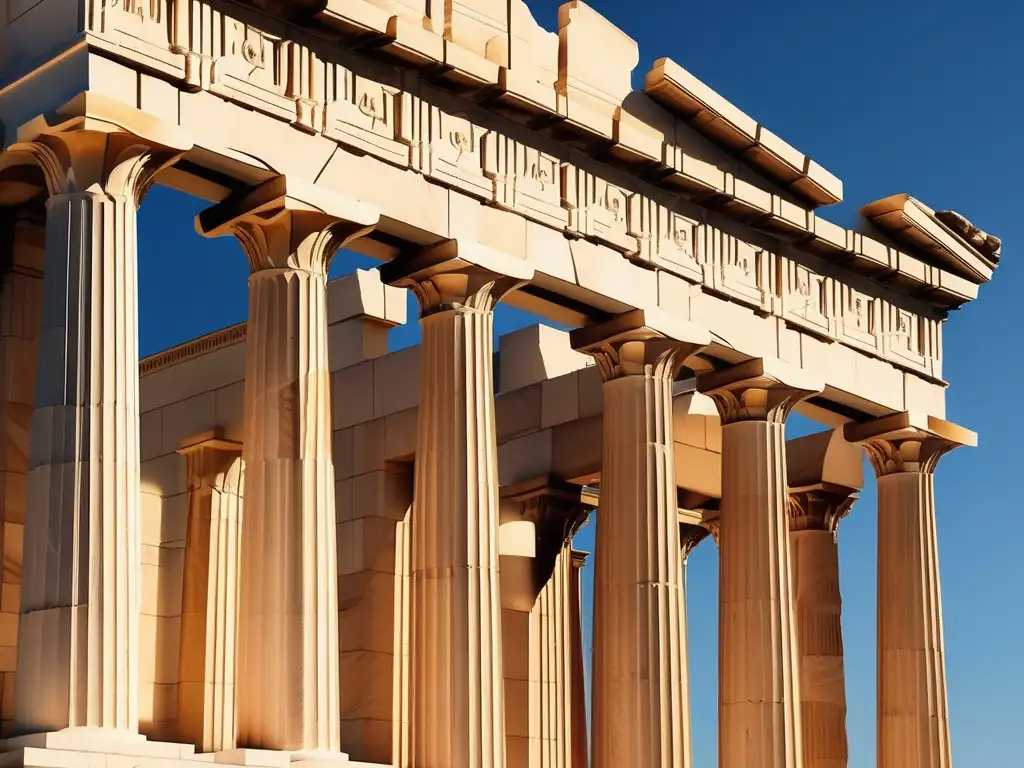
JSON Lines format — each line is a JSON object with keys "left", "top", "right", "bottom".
{"left": 697, "top": 357, "right": 824, "bottom": 426}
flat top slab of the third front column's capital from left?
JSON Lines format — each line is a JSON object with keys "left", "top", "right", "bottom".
{"left": 380, "top": 240, "right": 534, "bottom": 285}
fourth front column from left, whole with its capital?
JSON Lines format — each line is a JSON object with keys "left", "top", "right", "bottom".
{"left": 571, "top": 310, "right": 710, "bottom": 768}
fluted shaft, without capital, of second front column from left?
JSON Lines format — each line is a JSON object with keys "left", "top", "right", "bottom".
{"left": 239, "top": 266, "right": 341, "bottom": 751}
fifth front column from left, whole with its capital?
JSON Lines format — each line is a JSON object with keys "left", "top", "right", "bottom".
{"left": 697, "top": 359, "right": 823, "bottom": 768}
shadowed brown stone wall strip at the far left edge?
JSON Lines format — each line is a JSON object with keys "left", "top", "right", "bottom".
{"left": 0, "top": 219, "right": 43, "bottom": 736}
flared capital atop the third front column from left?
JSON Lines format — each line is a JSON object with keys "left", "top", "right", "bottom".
{"left": 381, "top": 240, "right": 534, "bottom": 317}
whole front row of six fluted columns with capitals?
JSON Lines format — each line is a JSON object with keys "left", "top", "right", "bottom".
{"left": 0, "top": 130, "right": 967, "bottom": 768}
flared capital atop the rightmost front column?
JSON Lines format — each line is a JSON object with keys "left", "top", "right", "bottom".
{"left": 844, "top": 411, "right": 978, "bottom": 477}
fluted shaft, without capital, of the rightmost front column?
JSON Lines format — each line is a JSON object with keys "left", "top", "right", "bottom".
{"left": 878, "top": 472, "right": 951, "bottom": 768}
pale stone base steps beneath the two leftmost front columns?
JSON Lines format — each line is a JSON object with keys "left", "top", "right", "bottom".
{"left": 0, "top": 741, "right": 390, "bottom": 768}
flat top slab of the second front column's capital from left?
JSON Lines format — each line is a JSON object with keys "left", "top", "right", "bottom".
{"left": 196, "top": 176, "right": 380, "bottom": 239}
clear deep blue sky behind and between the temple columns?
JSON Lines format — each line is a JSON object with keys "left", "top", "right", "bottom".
{"left": 139, "top": 0, "right": 1024, "bottom": 768}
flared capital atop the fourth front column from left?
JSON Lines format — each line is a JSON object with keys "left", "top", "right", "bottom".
{"left": 569, "top": 309, "right": 711, "bottom": 382}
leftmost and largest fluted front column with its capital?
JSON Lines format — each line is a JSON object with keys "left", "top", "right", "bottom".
{"left": 0, "top": 129, "right": 188, "bottom": 743}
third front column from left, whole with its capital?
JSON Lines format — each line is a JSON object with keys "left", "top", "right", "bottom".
{"left": 381, "top": 241, "right": 532, "bottom": 768}
